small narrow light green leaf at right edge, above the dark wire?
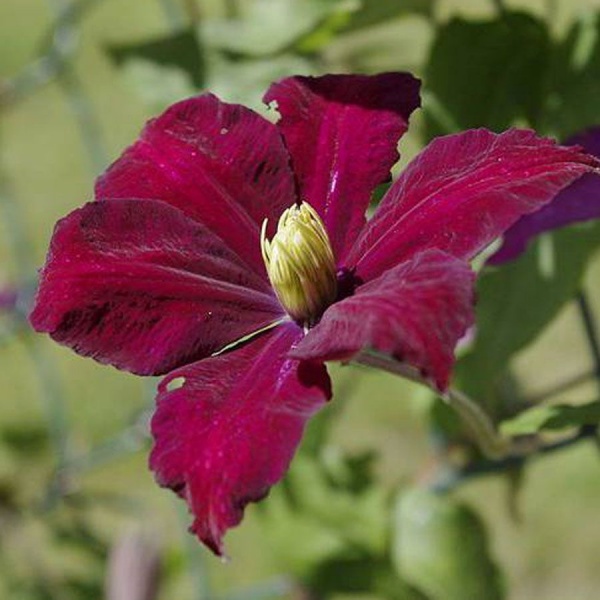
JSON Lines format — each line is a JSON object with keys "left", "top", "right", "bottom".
{"left": 500, "top": 401, "right": 600, "bottom": 436}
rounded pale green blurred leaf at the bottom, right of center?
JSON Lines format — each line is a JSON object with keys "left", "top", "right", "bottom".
{"left": 393, "top": 489, "right": 505, "bottom": 600}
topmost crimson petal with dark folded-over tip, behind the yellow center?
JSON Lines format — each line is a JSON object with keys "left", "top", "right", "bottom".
{"left": 264, "top": 73, "right": 420, "bottom": 260}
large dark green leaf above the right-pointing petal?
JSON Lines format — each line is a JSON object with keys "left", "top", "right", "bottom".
{"left": 425, "top": 12, "right": 550, "bottom": 137}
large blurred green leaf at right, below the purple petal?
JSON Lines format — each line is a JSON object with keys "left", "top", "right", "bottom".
{"left": 456, "top": 221, "right": 600, "bottom": 409}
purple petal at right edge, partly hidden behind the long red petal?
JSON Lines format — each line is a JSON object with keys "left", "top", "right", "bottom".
{"left": 488, "top": 127, "right": 600, "bottom": 265}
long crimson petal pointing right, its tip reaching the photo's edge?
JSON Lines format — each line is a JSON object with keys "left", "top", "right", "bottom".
{"left": 347, "top": 129, "right": 600, "bottom": 280}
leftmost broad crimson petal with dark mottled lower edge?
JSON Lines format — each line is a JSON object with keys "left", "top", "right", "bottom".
{"left": 31, "top": 200, "right": 282, "bottom": 375}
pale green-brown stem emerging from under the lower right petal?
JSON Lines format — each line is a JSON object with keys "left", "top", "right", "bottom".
{"left": 355, "top": 352, "right": 511, "bottom": 460}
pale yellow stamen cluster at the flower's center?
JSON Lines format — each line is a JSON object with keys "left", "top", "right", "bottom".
{"left": 260, "top": 202, "right": 337, "bottom": 326}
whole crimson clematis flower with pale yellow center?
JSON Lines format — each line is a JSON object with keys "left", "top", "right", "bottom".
{"left": 31, "top": 73, "right": 598, "bottom": 554}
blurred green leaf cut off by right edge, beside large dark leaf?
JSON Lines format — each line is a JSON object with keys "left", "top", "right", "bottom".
{"left": 542, "top": 13, "right": 600, "bottom": 139}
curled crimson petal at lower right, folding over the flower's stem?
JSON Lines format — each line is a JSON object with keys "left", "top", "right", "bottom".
{"left": 291, "top": 250, "right": 474, "bottom": 390}
